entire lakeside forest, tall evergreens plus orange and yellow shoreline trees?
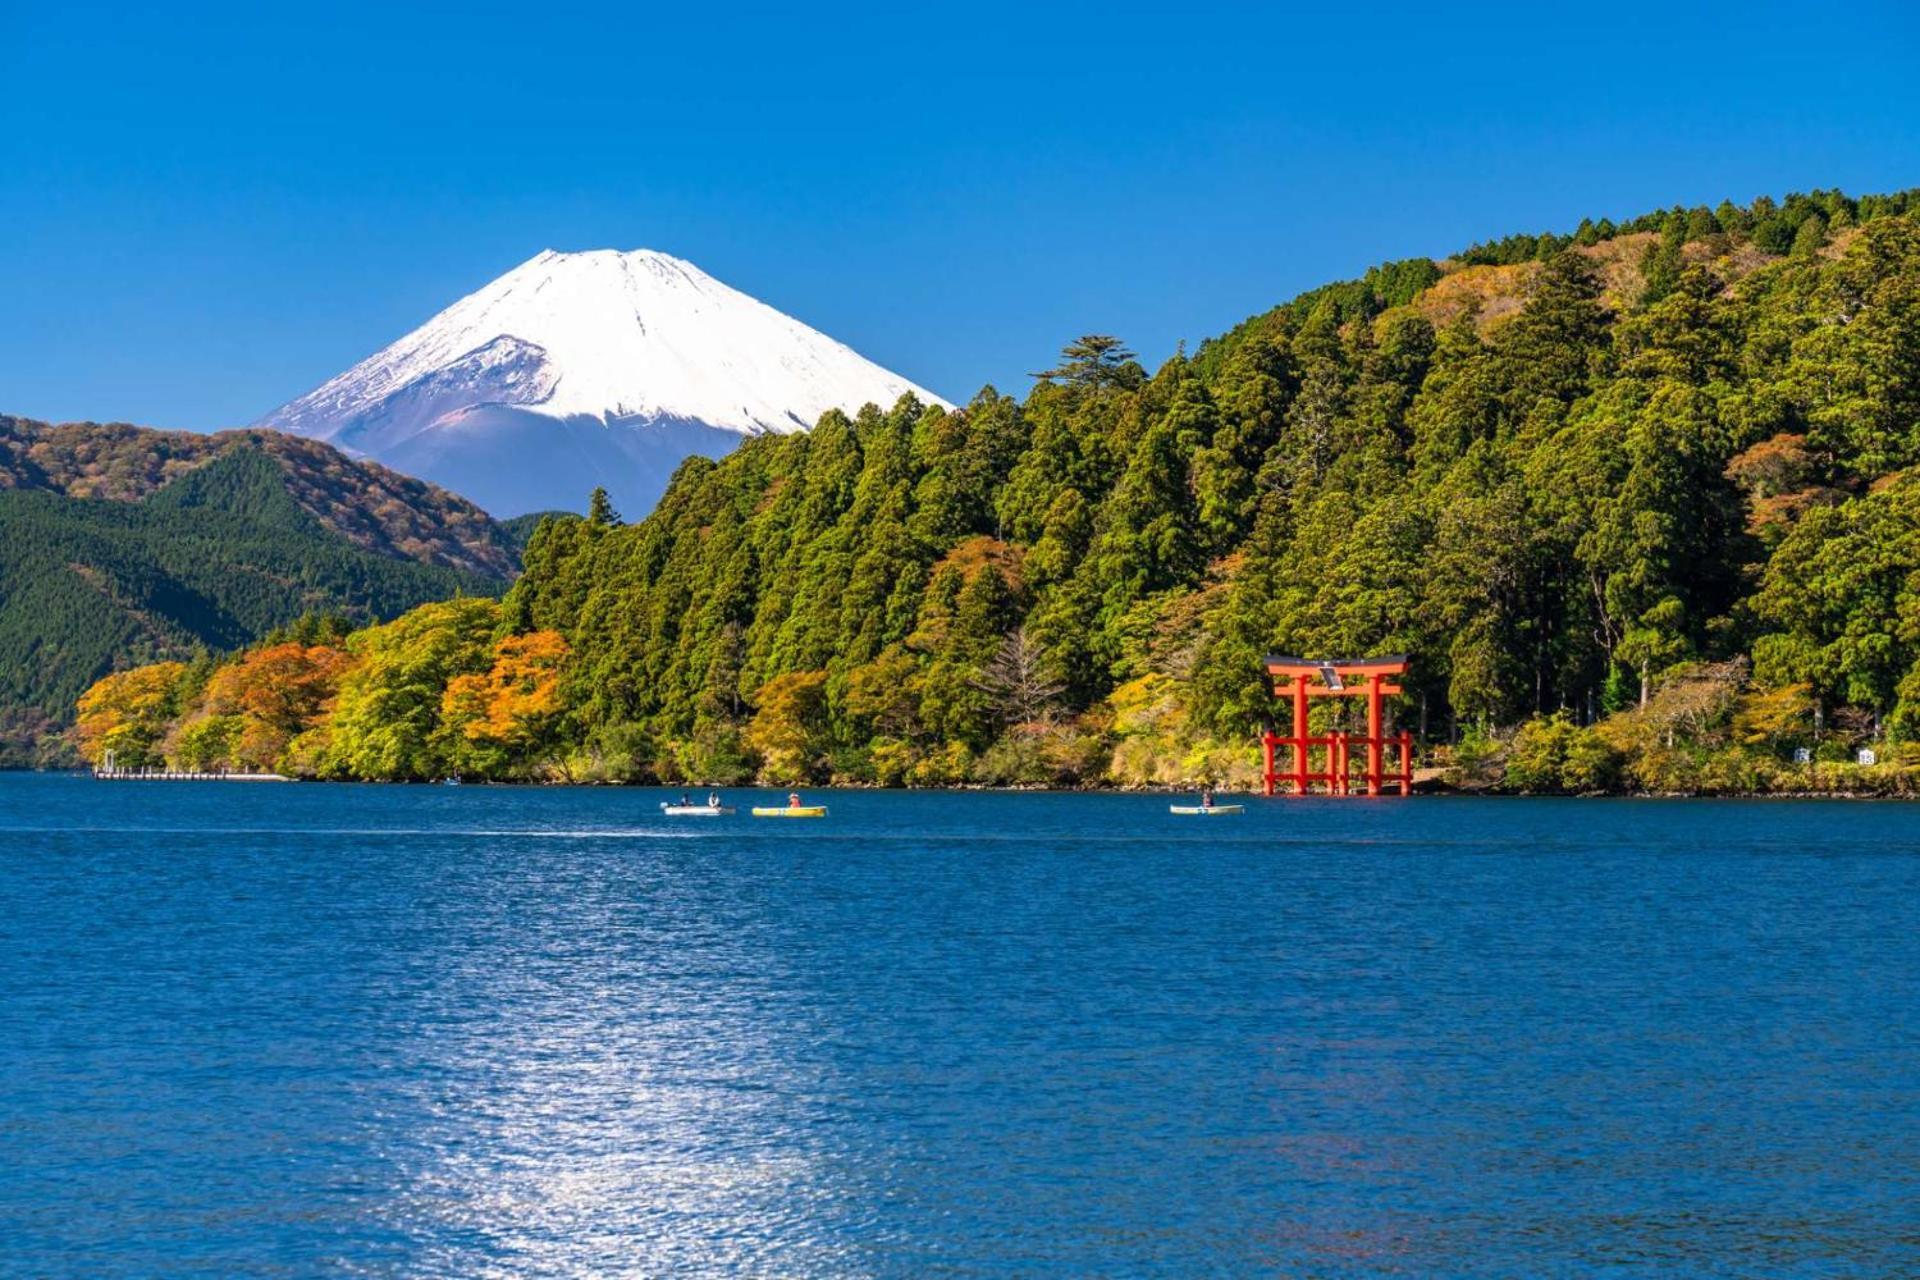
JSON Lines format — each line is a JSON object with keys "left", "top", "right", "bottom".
{"left": 81, "top": 192, "right": 1920, "bottom": 791}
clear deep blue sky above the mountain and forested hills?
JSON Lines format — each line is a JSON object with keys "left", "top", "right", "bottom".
{"left": 0, "top": 0, "right": 1920, "bottom": 428}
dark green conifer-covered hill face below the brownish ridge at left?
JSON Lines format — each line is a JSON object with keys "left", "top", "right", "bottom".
{"left": 0, "top": 439, "right": 505, "bottom": 764}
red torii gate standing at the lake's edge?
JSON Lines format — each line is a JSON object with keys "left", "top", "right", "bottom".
{"left": 1260, "top": 654, "right": 1413, "bottom": 796}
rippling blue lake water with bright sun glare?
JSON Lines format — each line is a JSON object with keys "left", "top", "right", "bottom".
{"left": 0, "top": 775, "right": 1920, "bottom": 1278}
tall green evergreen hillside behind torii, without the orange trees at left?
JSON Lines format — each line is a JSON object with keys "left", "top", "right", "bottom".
{"left": 509, "top": 194, "right": 1920, "bottom": 790}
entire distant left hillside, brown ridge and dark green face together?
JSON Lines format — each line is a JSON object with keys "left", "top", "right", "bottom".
{"left": 0, "top": 418, "right": 524, "bottom": 764}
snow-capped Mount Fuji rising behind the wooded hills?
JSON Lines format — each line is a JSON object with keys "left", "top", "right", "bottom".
{"left": 255, "top": 249, "right": 945, "bottom": 516}
